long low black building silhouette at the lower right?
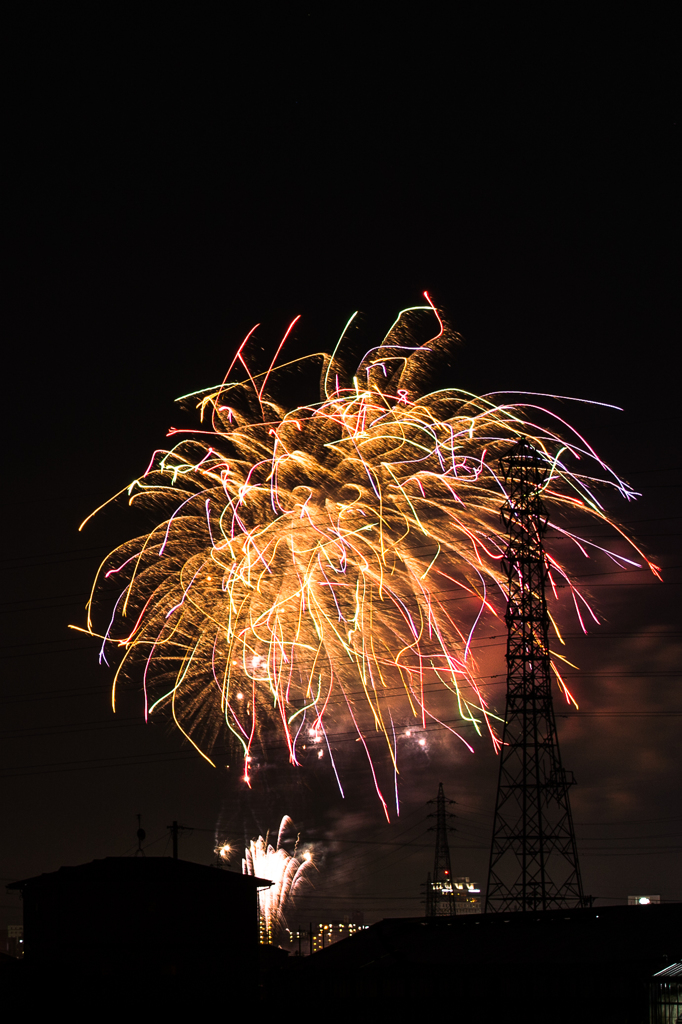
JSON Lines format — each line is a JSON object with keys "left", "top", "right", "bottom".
{"left": 301, "top": 903, "right": 682, "bottom": 1024}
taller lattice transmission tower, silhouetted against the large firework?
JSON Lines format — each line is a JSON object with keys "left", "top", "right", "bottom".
{"left": 485, "top": 438, "right": 589, "bottom": 912}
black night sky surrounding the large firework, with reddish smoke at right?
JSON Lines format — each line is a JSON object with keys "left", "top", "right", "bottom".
{"left": 0, "top": 5, "right": 682, "bottom": 923}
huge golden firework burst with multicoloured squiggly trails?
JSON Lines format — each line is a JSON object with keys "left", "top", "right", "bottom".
{"left": 76, "top": 296, "right": 655, "bottom": 809}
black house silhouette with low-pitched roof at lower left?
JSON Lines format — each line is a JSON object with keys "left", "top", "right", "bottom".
{"left": 7, "top": 857, "right": 271, "bottom": 969}
